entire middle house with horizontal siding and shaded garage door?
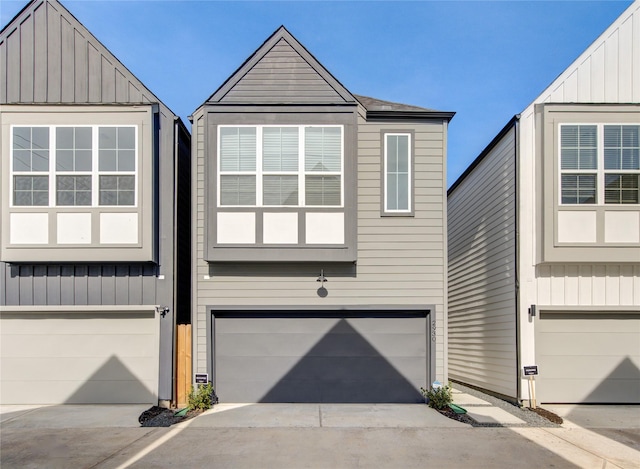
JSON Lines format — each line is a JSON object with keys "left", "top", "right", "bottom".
{"left": 191, "top": 27, "right": 453, "bottom": 402}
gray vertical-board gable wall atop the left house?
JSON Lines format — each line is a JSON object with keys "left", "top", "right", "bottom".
{"left": 0, "top": 0, "right": 168, "bottom": 104}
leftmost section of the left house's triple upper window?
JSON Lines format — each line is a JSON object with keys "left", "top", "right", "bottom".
{"left": 11, "top": 127, "right": 50, "bottom": 206}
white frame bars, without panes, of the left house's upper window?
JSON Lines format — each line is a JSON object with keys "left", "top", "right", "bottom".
{"left": 9, "top": 124, "right": 140, "bottom": 209}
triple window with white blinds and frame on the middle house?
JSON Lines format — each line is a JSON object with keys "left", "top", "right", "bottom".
{"left": 218, "top": 126, "right": 343, "bottom": 207}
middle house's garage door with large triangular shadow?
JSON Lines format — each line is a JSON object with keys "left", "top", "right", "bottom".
{"left": 214, "top": 312, "right": 428, "bottom": 402}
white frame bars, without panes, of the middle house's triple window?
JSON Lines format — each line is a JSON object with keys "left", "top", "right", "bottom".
{"left": 216, "top": 124, "right": 344, "bottom": 208}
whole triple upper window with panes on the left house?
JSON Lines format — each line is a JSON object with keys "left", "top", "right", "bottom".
{"left": 11, "top": 126, "right": 137, "bottom": 207}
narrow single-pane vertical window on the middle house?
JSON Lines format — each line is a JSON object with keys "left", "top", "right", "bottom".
{"left": 384, "top": 134, "right": 411, "bottom": 213}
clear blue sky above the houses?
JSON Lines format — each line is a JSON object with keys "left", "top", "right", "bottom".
{"left": 0, "top": 0, "right": 631, "bottom": 185}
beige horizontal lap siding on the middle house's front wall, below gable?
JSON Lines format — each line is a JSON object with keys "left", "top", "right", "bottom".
{"left": 193, "top": 114, "right": 446, "bottom": 378}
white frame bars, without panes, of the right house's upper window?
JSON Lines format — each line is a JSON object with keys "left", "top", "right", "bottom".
{"left": 556, "top": 122, "right": 640, "bottom": 207}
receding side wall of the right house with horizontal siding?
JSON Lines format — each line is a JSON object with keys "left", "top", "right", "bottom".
{"left": 448, "top": 126, "right": 518, "bottom": 397}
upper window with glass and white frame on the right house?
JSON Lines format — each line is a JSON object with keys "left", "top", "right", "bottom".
{"left": 560, "top": 124, "right": 640, "bottom": 204}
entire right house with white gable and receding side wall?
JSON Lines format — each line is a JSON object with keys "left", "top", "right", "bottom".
{"left": 448, "top": 1, "right": 640, "bottom": 403}
